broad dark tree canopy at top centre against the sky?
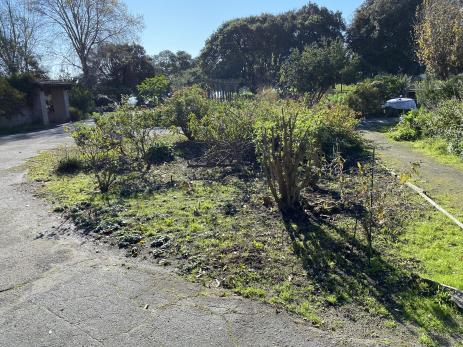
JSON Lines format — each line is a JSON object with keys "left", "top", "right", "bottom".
{"left": 199, "top": 3, "right": 345, "bottom": 90}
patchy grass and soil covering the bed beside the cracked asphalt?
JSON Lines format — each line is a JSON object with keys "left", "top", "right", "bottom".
{"left": 29, "top": 136, "right": 463, "bottom": 342}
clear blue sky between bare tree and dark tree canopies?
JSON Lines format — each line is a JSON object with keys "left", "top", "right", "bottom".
{"left": 126, "top": 0, "right": 363, "bottom": 56}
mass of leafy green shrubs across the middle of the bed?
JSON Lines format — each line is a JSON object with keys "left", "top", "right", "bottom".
{"left": 73, "top": 86, "right": 361, "bottom": 210}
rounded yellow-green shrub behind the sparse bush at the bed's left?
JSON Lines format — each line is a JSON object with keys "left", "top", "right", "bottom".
{"left": 158, "top": 86, "right": 210, "bottom": 140}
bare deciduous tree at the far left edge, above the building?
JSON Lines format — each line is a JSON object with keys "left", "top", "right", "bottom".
{"left": 0, "top": 0, "right": 40, "bottom": 76}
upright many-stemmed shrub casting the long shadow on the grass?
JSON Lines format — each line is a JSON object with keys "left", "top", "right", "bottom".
{"left": 260, "top": 103, "right": 319, "bottom": 212}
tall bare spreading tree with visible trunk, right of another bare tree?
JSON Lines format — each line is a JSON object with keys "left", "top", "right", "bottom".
{"left": 31, "top": 0, "right": 143, "bottom": 83}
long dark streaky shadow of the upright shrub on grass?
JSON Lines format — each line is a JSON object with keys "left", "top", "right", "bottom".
{"left": 283, "top": 210, "right": 458, "bottom": 346}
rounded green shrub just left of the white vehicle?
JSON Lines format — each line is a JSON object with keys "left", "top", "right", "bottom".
{"left": 347, "top": 75, "right": 410, "bottom": 116}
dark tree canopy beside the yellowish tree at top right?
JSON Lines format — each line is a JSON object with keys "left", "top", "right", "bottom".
{"left": 347, "top": 0, "right": 422, "bottom": 74}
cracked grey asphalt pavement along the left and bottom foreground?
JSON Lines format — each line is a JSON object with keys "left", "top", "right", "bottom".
{"left": 0, "top": 127, "right": 358, "bottom": 347}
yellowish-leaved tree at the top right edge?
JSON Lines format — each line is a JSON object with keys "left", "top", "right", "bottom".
{"left": 415, "top": 0, "right": 463, "bottom": 78}
